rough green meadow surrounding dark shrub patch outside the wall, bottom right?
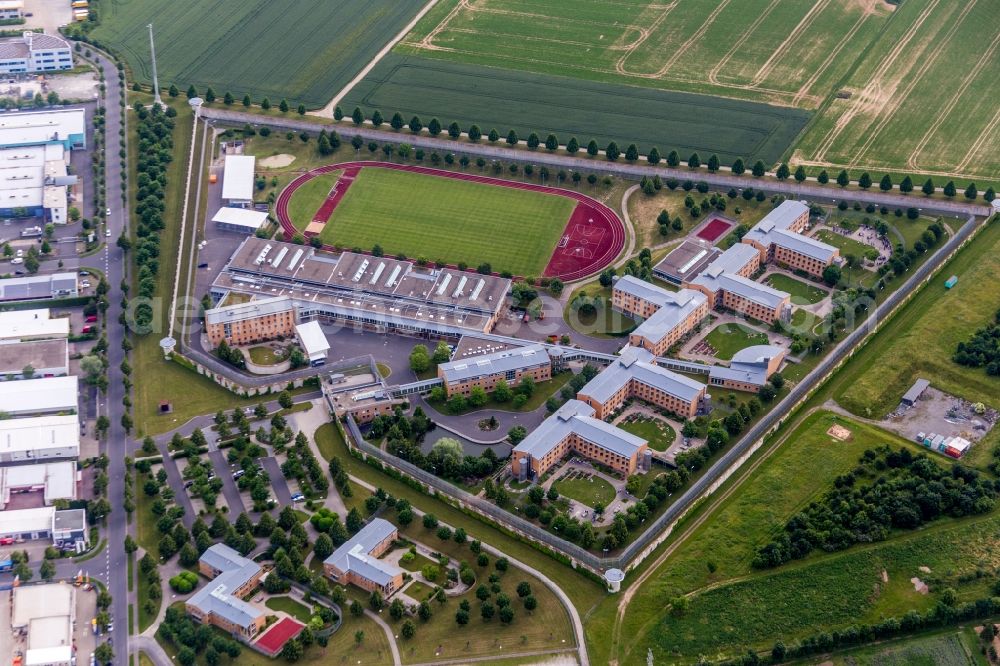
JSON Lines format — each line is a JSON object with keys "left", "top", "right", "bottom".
{"left": 587, "top": 411, "right": 1000, "bottom": 663}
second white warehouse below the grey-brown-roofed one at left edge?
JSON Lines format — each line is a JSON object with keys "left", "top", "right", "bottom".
{"left": 0, "top": 416, "right": 80, "bottom": 463}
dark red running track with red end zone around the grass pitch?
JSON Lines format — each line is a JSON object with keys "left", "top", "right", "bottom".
{"left": 275, "top": 161, "right": 625, "bottom": 282}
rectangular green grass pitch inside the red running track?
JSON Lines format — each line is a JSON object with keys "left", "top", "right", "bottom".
{"left": 312, "top": 168, "right": 575, "bottom": 275}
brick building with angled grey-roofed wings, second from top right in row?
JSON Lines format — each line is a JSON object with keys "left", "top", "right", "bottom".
{"left": 685, "top": 243, "right": 791, "bottom": 323}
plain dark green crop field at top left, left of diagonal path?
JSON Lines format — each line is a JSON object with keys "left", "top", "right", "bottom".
{"left": 93, "top": 0, "right": 424, "bottom": 106}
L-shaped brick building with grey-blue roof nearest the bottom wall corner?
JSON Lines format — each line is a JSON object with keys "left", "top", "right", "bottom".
{"left": 510, "top": 400, "right": 648, "bottom": 481}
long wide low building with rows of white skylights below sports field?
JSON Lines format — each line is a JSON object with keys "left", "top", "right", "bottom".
{"left": 211, "top": 237, "right": 511, "bottom": 337}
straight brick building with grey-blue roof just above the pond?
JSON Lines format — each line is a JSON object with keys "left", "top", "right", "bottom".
{"left": 438, "top": 345, "right": 552, "bottom": 398}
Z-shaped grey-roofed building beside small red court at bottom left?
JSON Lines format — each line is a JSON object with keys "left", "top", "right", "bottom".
{"left": 185, "top": 543, "right": 267, "bottom": 642}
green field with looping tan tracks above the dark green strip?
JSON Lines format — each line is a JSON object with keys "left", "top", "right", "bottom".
{"left": 396, "top": 0, "right": 891, "bottom": 108}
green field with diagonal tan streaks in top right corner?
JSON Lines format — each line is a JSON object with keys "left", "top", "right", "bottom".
{"left": 793, "top": 0, "right": 1000, "bottom": 180}
